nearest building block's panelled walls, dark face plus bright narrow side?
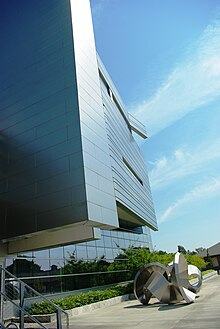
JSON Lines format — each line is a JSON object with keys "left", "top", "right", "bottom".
{"left": 0, "top": 0, "right": 118, "bottom": 240}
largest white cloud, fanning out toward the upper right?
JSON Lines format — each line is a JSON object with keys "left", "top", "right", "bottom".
{"left": 132, "top": 20, "right": 220, "bottom": 135}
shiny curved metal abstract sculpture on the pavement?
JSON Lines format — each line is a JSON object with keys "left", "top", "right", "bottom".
{"left": 134, "top": 252, "right": 202, "bottom": 304}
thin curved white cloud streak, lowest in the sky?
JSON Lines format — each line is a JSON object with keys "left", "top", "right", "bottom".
{"left": 158, "top": 178, "right": 220, "bottom": 224}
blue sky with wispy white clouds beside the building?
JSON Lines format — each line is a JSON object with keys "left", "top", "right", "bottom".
{"left": 91, "top": 0, "right": 220, "bottom": 251}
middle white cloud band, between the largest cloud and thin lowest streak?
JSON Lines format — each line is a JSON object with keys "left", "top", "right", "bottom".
{"left": 149, "top": 139, "right": 220, "bottom": 191}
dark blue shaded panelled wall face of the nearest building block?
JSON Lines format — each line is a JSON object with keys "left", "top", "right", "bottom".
{"left": 0, "top": 0, "right": 88, "bottom": 239}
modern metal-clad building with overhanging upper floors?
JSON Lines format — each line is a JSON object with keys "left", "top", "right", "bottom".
{"left": 0, "top": 0, "right": 157, "bottom": 288}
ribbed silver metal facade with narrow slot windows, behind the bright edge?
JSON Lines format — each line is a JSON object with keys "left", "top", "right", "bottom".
{"left": 98, "top": 58, "right": 157, "bottom": 230}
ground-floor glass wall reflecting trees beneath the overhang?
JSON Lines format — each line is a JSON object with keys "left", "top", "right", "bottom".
{"left": 6, "top": 227, "right": 152, "bottom": 293}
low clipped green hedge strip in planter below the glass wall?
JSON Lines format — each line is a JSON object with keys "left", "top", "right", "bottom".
{"left": 27, "top": 284, "right": 133, "bottom": 314}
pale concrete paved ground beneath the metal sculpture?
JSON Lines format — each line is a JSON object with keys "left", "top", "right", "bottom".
{"left": 70, "top": 276, "right": 220, "bottom": 329}
